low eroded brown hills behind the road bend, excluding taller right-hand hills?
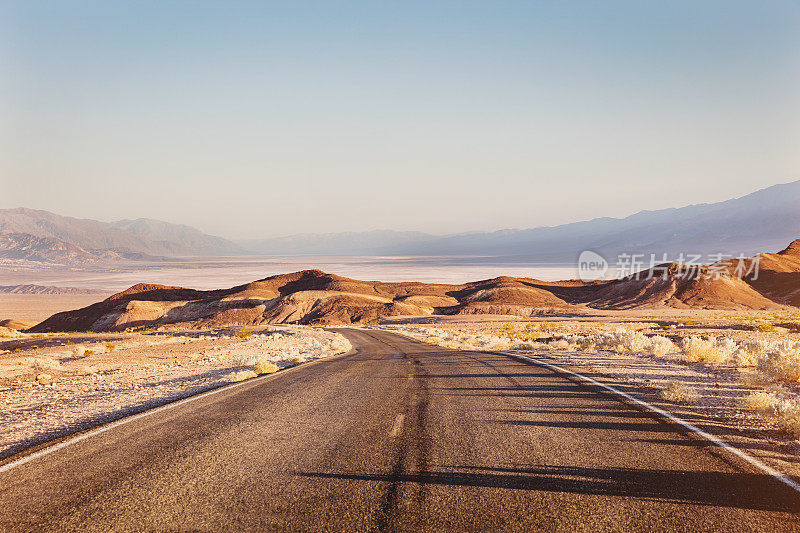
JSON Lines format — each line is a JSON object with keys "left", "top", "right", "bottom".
{"left": 31, "top": 270, "right": 573, "bottom": 332}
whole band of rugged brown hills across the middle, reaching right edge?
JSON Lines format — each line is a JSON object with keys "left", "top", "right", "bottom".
{"left": 31, "top": 240, "right": 800, "bottom": 332}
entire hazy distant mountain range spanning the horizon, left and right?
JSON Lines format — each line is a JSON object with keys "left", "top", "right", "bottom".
{"left": 0, "top": 181, "right": 800, "bottom": 264}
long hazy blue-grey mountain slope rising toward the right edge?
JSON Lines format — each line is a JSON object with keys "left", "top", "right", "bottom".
{"left": 241, "top": 181, "right": 800, "bottom": 263}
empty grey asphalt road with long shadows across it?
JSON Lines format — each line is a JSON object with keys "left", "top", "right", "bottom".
{"left": 0, "top": 330, "right": 800, "bottom": 531}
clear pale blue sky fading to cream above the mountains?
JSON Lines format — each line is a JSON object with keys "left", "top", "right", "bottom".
{"left": 0, "top": 0, "right": 800, "bottom": 238}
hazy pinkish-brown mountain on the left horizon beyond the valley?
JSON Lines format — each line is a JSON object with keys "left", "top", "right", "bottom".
{"left": 0, "top": 208, "right": 242, "bottom": 263}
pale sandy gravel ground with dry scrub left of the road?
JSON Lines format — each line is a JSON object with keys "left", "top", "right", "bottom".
{"left": 0, "top": 326, "right": 351, "bottom": 460}
